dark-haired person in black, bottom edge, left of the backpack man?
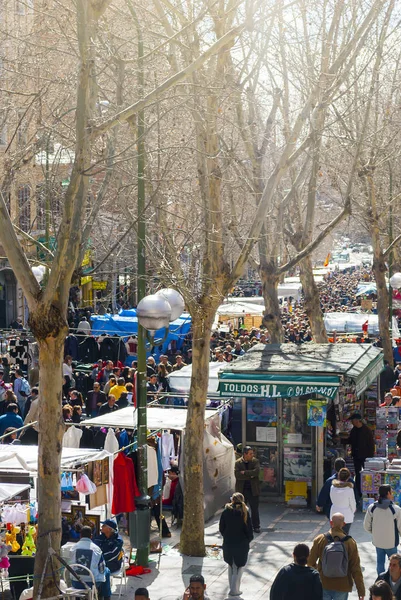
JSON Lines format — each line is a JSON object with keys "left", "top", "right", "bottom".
{"left": 270, "top": 544, "right": 323, "bottom": 600}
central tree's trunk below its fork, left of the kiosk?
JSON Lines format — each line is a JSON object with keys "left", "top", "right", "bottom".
{"left": 180, "top": 307, "right": 217, "bottom": 556}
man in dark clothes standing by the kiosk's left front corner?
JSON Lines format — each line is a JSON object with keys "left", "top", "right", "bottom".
{"left": 234, "top": 446, "right": 260, "bottom": 533}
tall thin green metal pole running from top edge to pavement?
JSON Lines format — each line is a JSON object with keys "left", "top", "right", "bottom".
{"left": 128, "top": 2, "right": 150, "bottom": 567}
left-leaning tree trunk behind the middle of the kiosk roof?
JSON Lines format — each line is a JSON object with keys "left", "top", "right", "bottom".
{"left": 299, "top": 255, "right": 328, "bottom": 344}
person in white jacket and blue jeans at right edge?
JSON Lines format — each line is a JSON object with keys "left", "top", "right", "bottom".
{"left": 363, "top": 484, "right": 401, "bottom": 575}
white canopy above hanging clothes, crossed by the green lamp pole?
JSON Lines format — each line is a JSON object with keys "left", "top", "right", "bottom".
{"left": 81, "top": 406, "right": 222, "bottom": 430}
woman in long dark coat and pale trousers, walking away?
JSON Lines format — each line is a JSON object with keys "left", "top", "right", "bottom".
{"left": 219, "top": 492, "right": 253, "bottom": 596}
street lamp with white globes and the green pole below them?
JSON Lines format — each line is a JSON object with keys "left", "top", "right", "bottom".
{"left": 130, "top": 289, "right": 185, "bottom": 567}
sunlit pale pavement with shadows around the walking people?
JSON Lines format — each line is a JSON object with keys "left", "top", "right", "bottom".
{"left": 118, "top": 504, "right": 376, "bottom": 600}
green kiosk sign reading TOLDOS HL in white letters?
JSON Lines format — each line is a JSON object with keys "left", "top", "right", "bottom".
{"left": 219, "top": 380, "right": 338, "bottom": 398}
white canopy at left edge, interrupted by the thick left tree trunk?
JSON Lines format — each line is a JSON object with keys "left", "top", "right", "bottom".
{"left": 0, "top": 444, "right": 109, "bottom": 472}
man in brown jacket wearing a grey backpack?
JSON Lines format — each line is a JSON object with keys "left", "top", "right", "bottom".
{"left": 308, "top": 513, "right": 365, "bottom": 600}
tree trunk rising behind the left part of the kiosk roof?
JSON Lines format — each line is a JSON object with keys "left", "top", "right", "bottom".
{"left": 259, "top": 264, "right": 284, "bottom": 344}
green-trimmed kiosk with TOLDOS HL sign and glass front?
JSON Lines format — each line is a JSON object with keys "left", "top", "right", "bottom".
{"left": 219, "top": 343, "right": 383, "bottom": 504}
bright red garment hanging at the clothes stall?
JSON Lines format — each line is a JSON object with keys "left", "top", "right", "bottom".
{"left": 111, "top": 452, "right": 140, "bottom": 515}
